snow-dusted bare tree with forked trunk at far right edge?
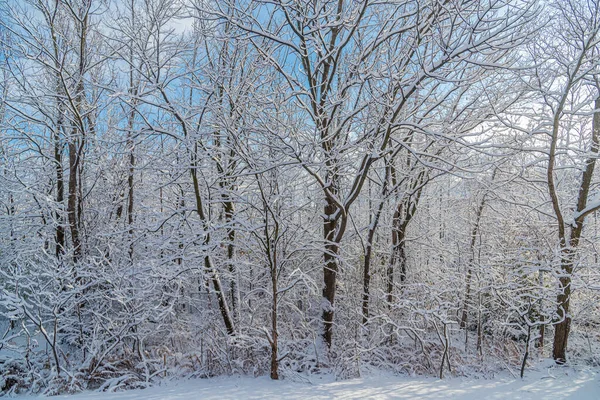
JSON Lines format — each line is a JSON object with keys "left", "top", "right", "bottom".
{"left": 533, "top": 1, "right": 600, "bottom": 363}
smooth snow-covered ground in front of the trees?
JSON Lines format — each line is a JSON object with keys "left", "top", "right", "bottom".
{"left": 19, "top": 366, "right": 600, "bottom": 400}
